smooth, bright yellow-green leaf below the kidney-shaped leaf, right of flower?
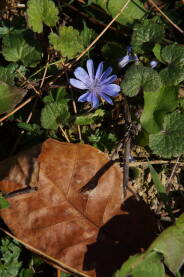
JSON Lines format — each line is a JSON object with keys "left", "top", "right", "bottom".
{"left": 140, "top": 86, "right": 178, "bottom": 134}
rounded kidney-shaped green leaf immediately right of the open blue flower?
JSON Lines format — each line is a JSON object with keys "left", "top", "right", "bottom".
{"left": 121, "top": 65, "right": 161, "bottom": 97}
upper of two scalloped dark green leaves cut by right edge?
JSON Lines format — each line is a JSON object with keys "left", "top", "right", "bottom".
{"left": 160, "top": 44, "right": 184, "bottom": 85}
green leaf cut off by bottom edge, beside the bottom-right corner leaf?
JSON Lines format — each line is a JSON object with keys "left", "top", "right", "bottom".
{"left": 113, "top": 251, "right": 165, "bottom": 277}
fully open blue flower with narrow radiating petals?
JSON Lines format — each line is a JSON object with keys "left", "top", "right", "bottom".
{"left": 70, "top": 59, "right": 120, "bottom": 108}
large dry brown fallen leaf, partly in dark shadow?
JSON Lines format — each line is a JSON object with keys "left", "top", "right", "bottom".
{"left": 0, "top": 139, "right": 156, "bottom": 277}
